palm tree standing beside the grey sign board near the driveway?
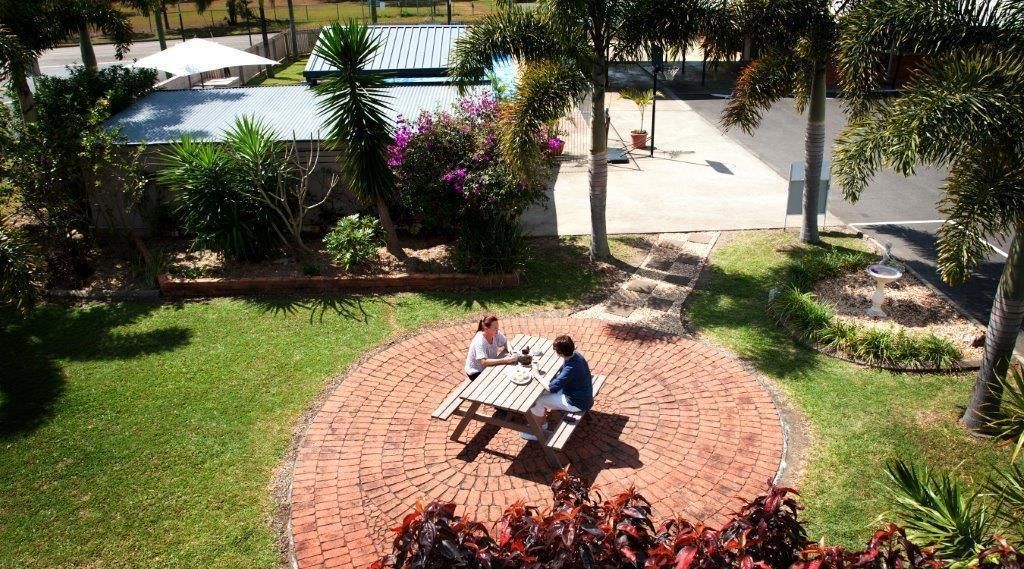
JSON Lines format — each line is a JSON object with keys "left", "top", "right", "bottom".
{"left": 711, "top": 0, "right": 839, "bottom": 243}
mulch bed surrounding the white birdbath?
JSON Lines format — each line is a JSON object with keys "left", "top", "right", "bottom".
{"left": 814, "top": 271, "right": 984, "bottom": 361}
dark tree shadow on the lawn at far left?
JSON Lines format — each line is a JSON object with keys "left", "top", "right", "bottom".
{"left": 0, "top": 303, "right": 191, "bottom": 436}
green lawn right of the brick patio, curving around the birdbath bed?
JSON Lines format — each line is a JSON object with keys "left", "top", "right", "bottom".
{"left": 689, "top": 231, "right": 1010, "bottom": 545}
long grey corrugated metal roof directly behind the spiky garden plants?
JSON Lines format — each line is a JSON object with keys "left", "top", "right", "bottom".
{"left": 106, "top": 85, "right": 482, "bottom": 144}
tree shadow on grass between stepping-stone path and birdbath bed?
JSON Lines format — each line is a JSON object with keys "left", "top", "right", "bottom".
{"left": 683, "top": 233, "right": 863, "bottom": 379}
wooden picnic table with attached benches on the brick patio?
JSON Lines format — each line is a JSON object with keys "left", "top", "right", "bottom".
{"left": 431, "top": 334, "right": 605, "bottom": 468}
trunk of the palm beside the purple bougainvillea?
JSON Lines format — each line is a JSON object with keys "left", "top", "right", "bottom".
{"left": 590, "top": 57, "right": 610, "bottom": 260}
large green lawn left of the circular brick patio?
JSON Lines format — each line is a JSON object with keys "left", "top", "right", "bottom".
{"left": 0, "top": 235, "right": 625, "bottom": 568}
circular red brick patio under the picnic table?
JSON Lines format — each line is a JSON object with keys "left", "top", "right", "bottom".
{"left": 291, "top": 318, "right": 782, "bottom": 568}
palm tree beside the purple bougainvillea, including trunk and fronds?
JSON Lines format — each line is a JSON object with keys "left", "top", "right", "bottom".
{"left": 451, "top": 0, "right": 712, "bottom": 259}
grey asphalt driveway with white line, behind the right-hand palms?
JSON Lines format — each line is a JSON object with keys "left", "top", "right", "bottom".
{"left": 686, "top": 97, "right": 1009, "bottom": 322}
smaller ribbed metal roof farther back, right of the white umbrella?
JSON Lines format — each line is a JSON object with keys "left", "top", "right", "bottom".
{"left": 302, "top": 26, "right": 468, "bottom": 79}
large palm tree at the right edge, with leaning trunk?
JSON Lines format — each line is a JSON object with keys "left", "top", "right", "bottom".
{"left": 834, "top": 0, "right": 1024, "bottom": 431}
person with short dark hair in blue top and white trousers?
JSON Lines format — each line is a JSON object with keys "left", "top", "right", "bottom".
{"left": 522, "top": 336, "right": 594, "bottom": 440}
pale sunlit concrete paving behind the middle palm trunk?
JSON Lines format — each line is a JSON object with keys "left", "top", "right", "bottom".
{"left": 523, "top": 93, "right": 787, "bottom": 235}
